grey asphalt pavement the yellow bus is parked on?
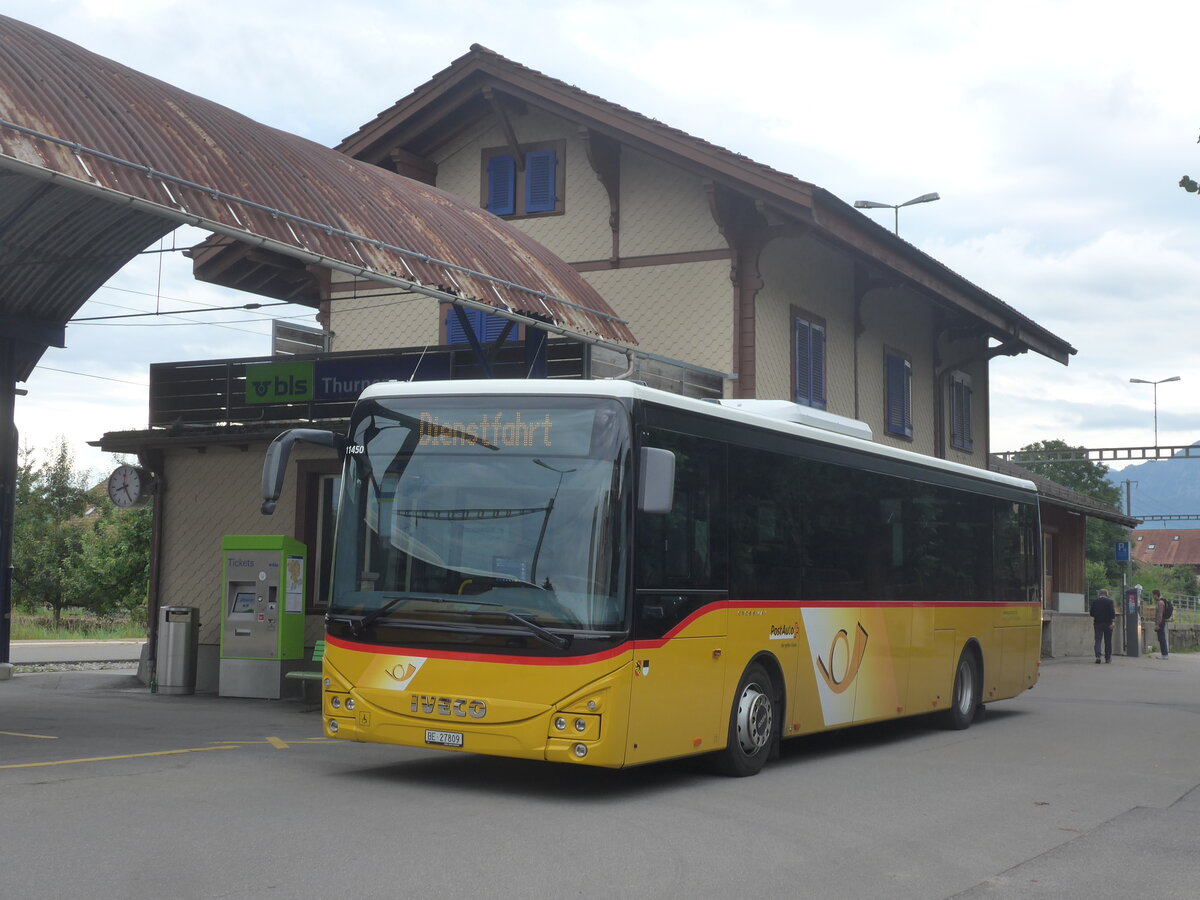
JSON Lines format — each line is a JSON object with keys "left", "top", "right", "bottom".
{"left": 0, "top": 654, "right": 1200, "bottom": 900}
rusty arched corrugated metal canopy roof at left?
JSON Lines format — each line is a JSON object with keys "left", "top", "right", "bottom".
{"left": 0, "top": 17, "right": 636, "bottom": 381}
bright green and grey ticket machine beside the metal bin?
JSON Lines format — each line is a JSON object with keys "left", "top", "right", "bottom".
{"left": 218, "top": 534, "right": 306, "bottom": 700}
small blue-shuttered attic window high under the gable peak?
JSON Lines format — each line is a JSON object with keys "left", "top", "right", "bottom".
{"left": 480, "top": 140, "right": 565, "bottom": 218}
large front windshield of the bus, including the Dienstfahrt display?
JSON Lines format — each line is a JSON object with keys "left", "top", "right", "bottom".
{"left": 329, "top": 396, "right": 629, "bottom": 647}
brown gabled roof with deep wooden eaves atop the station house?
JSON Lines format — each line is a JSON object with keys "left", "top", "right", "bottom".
{"left": 337, "top": 44, "right": 1075, "bottom": 364}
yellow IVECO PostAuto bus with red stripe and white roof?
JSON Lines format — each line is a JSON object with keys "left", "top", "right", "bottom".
{"left": 263, "top": 380, "right": 1042, "bottom": 775}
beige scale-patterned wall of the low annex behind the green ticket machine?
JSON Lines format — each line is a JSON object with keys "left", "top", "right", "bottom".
{"left": 156, "top": 443, "right": 326, "bottom": 691}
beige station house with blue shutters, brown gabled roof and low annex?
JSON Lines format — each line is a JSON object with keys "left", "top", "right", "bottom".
{"left": 98, "top": 46, "right": 1081, "bottom": 689}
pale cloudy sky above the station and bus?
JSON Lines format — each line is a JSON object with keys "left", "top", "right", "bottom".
{"left": 2, "top": 0, "right": 1200, "bottom": 487}
